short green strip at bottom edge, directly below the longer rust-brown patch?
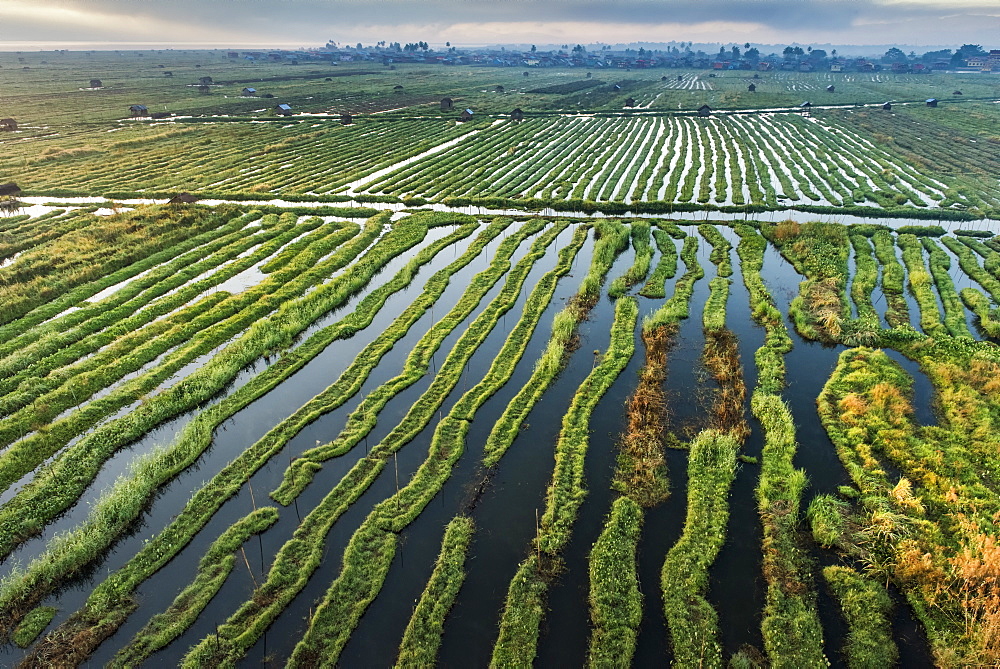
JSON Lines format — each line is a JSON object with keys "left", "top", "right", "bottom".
{"left": 587, "top": 497, "right": 643, "bottom": 667}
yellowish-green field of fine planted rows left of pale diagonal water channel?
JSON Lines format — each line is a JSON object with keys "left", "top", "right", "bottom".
{"left": 7, "top": 121, "right": 456, "bottom": 194}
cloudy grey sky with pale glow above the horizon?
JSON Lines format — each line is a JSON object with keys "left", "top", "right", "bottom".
{"left": 0, "top": 0, "right": 1000, "bottom": 50}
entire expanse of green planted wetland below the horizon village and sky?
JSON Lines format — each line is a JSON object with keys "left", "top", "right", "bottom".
{"left": 0, "top": 51, "right": 1000, "bottom": 667}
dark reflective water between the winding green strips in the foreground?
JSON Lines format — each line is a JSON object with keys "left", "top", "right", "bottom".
{"left": 0, "top": 218, "right": 944, "bottom": 667}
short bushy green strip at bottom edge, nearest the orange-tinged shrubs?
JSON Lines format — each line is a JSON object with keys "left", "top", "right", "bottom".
{"left": 823, "top": 566, "right": 899, "bottom": 669}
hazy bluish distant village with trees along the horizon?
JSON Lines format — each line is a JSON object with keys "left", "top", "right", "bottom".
{"left": 228, "top": 42, "right": 1000, "bottom": 73}
